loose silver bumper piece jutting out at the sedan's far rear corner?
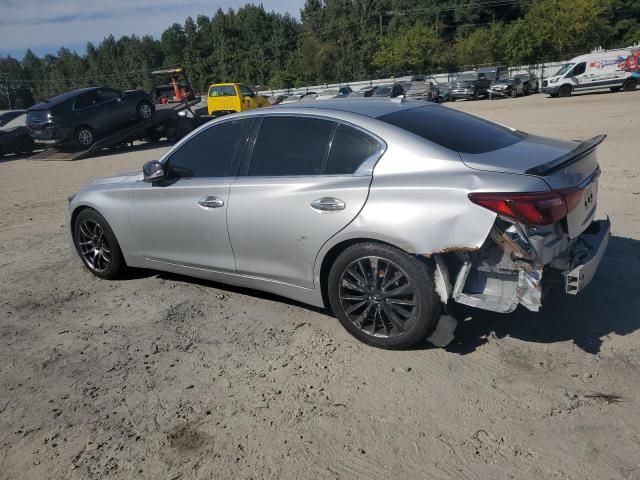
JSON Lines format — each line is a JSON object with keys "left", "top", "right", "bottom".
{"left": 562, "top": 218, "right": 611, "bottom": 295}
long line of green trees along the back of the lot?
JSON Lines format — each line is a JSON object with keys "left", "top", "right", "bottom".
{"left": 0, "top": 0, "right": 640, "bottom": 109}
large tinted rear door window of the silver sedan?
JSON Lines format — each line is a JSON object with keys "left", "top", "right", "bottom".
{"left": 248, "top": 116, "right": 335, "bottom": 177}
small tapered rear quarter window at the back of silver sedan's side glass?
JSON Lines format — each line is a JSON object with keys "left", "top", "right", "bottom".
{"left": 324, "top": 125, "right": 381, "bottom": 175}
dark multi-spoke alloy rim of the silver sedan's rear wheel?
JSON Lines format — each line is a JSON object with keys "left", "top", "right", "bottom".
{"left": 339, "top": 256, "right": 418, "bottom": 338}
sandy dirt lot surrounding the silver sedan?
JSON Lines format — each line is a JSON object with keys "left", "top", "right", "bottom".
{"left": 0, "top": 91, "right": 640, "bottom": 480}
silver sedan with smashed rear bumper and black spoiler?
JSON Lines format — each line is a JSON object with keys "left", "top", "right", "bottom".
{"left": 67, "top": 99, "right": 609, "bottom": 348}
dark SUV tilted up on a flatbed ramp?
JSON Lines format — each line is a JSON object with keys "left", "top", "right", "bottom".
{"left": 27, "top": 87, "right": 154, "bottom": 149}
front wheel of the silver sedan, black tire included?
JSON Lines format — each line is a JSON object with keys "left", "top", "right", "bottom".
{"left": 73, "top": 208, "right": 127, "bottom": 280}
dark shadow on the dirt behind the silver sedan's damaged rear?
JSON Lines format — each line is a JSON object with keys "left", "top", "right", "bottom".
{"left": 446, "top": 236, "right": 640, "bottom": 355}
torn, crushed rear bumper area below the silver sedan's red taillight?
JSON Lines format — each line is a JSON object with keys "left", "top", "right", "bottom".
{"left": 451, "top": 218, "right": 611, "bottom": 313}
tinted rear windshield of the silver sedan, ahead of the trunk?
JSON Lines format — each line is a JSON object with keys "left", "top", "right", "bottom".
{"left": 378, "top": 105, "right": 525, "bottom": 153}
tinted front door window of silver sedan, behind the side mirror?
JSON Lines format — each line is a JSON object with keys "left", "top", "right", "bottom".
{"left": 168, "top": 119, "right": 253, "bottom": 178}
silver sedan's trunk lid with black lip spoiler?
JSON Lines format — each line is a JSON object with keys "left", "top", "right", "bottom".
{"left": 460, "top": 135, "right": 604, "bottom": 238}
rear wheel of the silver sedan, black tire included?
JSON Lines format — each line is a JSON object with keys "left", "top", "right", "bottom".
{"left": 327, "top": 242, "right": 441, "bottom": 349}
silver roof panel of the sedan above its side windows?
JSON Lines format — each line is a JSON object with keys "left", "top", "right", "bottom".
{"left": 268, "top": 98, "right": 432, "bottom": 118}
